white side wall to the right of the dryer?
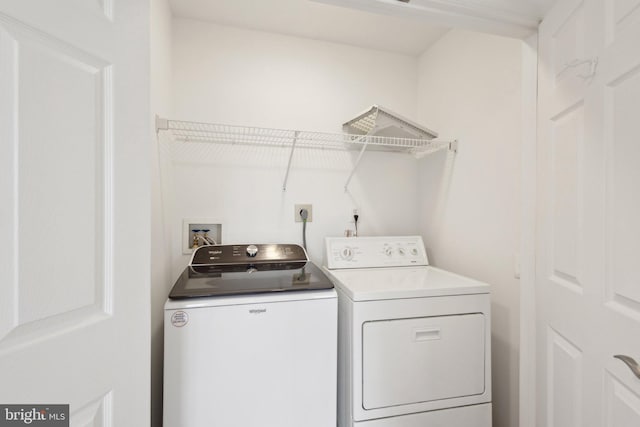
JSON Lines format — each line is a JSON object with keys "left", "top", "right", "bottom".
{"left": 418, "top": 31, "right": 523, "bottom": 427}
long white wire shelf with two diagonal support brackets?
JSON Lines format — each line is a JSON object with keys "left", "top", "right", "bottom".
{"left": 156, "top": 117, "right": 458, "bottom": 190}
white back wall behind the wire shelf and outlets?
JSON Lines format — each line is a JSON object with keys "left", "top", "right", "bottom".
{"left": 172, "top": 19, "right": 418, "bottom": 276}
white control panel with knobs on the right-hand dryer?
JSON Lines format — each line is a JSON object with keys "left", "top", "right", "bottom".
{"left": 325, "top": 236, "right": 429, "bottom": 270}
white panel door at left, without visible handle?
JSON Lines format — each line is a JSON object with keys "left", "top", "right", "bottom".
{"left": 0, "top": 0, "right": 149, "bottom": 426}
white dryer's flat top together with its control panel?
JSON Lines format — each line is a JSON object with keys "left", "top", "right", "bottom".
{"left": 325, "top": 236, "right": 489, "bottom": 301}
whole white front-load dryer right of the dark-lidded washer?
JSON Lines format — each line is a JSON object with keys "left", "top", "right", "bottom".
{"left": 325, "top": 236, "right": 491, "bottom": 427}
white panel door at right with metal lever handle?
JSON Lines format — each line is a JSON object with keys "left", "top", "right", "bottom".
{"left": 536, "top": 0, "right": 640, "bottom": 427}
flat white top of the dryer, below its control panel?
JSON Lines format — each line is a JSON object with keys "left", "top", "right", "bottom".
{"left": 325, "top": 266, "right": 489, "bottom": 301}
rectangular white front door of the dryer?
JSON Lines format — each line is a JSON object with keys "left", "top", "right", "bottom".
{"left": 362, "top": 313, "right": 486, "bottom": 409}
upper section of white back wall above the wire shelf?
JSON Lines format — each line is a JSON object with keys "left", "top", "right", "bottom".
{"left": 174, "top": 19, "right": 418, "bottom": 132}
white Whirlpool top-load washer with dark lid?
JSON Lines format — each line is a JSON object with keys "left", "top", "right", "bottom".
{"left": 163, "top": 244, "right": 337, "bottom": 427}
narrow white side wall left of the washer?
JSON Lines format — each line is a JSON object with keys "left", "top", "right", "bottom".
{"left": 150, "top": 0, "right": 173, "bottom": 427}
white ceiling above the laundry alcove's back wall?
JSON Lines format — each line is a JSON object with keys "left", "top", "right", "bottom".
{"left": 169, "top": 0, "right": 554, "bottom": 55}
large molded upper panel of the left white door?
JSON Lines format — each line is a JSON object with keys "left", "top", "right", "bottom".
{"left": 0, "top": 14, "right": 114, "bottom": 351}
